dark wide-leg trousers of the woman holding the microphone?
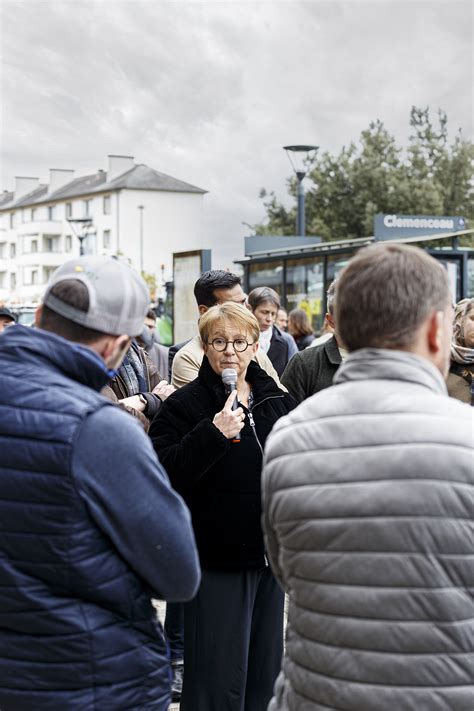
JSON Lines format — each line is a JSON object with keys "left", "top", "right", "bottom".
{"left": 180, "top": 567, "right": 284, "bottom": 711}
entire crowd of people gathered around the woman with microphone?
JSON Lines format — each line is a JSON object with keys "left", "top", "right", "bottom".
{"left": 0, "top": 243, "right": 474, "bottom": 711}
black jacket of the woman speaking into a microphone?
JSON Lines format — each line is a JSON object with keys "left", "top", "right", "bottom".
{"left": 149, "top": 357, "right": 294, "bottom": 570}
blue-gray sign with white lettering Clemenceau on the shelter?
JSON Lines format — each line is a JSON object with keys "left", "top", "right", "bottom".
{"left": 374, "top": 213, "right": 467, "bottom": 240}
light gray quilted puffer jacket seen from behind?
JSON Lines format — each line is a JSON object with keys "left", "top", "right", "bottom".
{"left": 262, "top": 349, "right": 474, "bottom": 711}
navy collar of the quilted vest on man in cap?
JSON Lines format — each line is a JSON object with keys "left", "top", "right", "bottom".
{"left": 0, "top": 325, "right": 112, "bottom": 391}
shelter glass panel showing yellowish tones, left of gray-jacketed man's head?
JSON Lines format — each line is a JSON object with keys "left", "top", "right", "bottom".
{"left": 286, "top": 257, "right": 324, "bottom": 333}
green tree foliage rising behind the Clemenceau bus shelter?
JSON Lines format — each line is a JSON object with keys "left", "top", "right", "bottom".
{"left": 255, "top": 106, "right": 474, "bottom": 240}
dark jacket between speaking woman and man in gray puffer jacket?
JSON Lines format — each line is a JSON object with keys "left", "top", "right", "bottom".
{"left": 281, "top": 336, "right": 342, "bottom": 403}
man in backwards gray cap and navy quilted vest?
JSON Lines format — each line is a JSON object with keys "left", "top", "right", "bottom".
{"left": 0, "top": 256, "right": 199, "bottom": 711}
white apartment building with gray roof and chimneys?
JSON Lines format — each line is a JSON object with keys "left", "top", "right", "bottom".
{"left": 0, "top": 155, "right": 206, "bottom": 304}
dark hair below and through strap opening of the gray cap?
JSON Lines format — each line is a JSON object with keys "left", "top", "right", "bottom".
{"left": 38, "top": 279, "right": 108, "bottom": 343}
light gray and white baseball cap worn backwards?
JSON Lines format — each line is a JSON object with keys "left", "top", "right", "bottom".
{"left": 43, "top": 255, "right": 150, "bottom": 336}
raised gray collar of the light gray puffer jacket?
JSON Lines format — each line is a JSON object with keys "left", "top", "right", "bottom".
{"left": 334, "top": 348, "right": 447, "bottom": 395}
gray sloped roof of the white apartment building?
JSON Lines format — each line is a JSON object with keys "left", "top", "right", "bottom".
{"left": 0, "top": 163, "right": 207, "bottom": 210}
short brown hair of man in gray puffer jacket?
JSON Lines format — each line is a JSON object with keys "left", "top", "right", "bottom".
{"left": 336, "top": 244, "right": 450, "bottom": 351}
